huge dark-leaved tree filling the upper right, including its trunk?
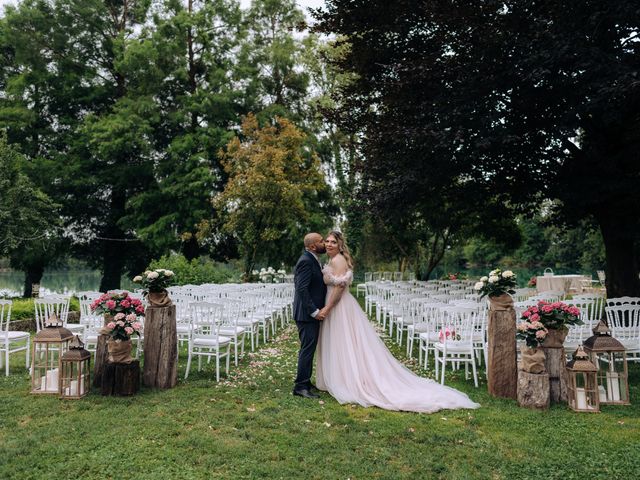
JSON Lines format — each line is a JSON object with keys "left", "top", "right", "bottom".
{"left": 317, "top": 0, "right": 640, "bottom": 296}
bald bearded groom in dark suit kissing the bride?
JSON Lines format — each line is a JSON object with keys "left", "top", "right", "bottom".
{"left": 293, "top": 233, "right": 327, "bottom": 398}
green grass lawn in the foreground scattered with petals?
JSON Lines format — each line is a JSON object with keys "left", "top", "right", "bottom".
{"left": 0, "top": 294, "right": 640, "bottom": 480}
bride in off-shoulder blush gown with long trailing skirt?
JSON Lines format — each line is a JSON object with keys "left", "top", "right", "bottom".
{"left": 316, "top": 231, "right": 480, "bottom": 413}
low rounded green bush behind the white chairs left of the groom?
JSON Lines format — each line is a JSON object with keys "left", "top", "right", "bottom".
{"left": 148, "top": 254, "right": 242, "bottom": 285}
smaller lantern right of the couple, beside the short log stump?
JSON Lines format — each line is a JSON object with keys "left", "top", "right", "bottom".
{"left": 567, "top": 346, "right": 600, "bottom": 413}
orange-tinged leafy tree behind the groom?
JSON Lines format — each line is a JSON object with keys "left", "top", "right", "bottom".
{"left": 215, "top": 115, "right": 327, "bottom": 277}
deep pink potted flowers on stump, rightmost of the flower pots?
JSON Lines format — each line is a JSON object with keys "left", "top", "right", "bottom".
{"left": 522, "top": 300, "right": 583, "bottom": 348}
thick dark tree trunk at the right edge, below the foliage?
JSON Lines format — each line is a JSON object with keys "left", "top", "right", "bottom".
{"left": 598, "top": 212, "right": 640, "bottom": 298}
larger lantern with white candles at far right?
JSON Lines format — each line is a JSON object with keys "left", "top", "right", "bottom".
{"left": 584, "top": 320, "right": 630, "bottom": 405}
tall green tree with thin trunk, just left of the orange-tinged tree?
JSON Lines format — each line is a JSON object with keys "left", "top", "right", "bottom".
{"left": 125, "top": 0, "right": 250, "bottom": 259}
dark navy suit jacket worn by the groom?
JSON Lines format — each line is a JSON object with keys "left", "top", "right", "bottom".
{"left": 293, "top": 251, "right": 327, "bottom": 322}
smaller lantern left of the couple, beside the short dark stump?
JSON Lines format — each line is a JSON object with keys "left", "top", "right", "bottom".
{"left": 60, "top": 335, "right": 91, "bottom": 398}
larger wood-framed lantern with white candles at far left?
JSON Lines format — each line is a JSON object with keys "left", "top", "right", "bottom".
{"left": 31, "top": 315, "right": 73, "bottom": 395}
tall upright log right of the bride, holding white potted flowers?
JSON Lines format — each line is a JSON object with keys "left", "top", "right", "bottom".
{"left": 487, "top": 294, "right": 518, "bottom": 399}
